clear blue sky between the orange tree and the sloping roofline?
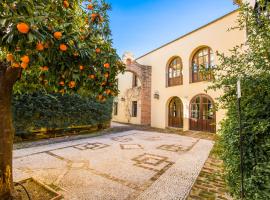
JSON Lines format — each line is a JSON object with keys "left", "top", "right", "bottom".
{"left": 107, "top": 0, "right": 237, "bottom": 57}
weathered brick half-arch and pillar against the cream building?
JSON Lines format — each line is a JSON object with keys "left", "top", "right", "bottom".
{"left": 126, "top": 60, "right": 152, "bottom": 125}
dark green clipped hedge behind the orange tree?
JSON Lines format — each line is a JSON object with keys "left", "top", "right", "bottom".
{"left": 13, "top": 93, "right": 112, "bottom": 135}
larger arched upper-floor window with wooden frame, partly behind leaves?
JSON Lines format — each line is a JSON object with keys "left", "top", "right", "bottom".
{"left": 191, "top": 47, "right": 214, "bottom": 83}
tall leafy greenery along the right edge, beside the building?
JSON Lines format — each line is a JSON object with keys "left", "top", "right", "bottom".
{"left": 211, "top": 0, "right": 270, "bottom": 200}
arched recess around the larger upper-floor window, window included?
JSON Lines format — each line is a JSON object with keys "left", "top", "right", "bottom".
{"left": 189, "top": 45, "right": 214, "bottom": 83}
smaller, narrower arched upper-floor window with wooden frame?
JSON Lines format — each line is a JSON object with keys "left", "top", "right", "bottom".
{"left": 167, "top": 57, "right": 183, "bottom": 87}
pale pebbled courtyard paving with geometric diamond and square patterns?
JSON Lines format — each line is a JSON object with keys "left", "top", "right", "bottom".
{"left": 14, "top": 130, "right": 213, "bottom": 200}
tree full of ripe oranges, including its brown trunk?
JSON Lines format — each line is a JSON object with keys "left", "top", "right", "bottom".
{"left": 0, "top": 0, "right": 124, "bottom": 199}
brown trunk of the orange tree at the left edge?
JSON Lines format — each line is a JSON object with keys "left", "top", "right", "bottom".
{"left": 0, "top": 62, "right": 19, "bottom": 200}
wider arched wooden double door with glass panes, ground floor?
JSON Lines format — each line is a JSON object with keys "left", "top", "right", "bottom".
{"left": 189, "top": 95, "right": 216, "bottom": 133}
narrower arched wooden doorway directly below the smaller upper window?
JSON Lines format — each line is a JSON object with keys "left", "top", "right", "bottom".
{"left": 168, "top": 97, "right": 183, "bottom": 128}
